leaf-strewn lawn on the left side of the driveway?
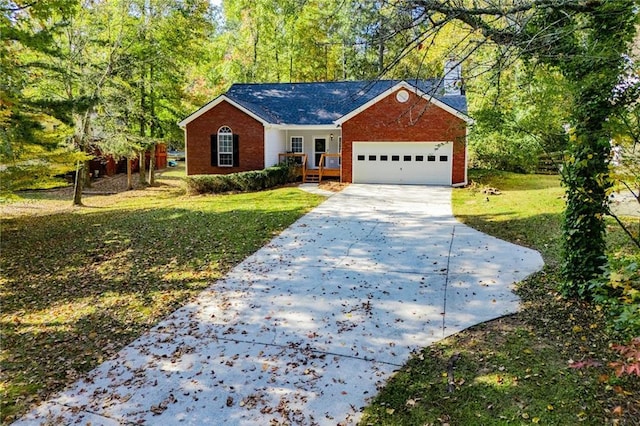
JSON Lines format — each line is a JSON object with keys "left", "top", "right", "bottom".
{"left": 0, "top": 172, "right": 322, "bottom": 423}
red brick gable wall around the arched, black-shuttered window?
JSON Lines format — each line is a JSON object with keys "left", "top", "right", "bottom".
{"left": 186, "top": 101, "right": 264, "bottom": 175}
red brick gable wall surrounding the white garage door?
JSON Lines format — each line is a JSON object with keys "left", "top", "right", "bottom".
{"left": 342, "top": 92, "right": 466, "bottom": 184}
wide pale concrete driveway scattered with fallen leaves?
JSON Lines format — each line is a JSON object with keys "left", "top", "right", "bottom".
{"left": 17, "top": 185, "right": 543, "bottom": 425}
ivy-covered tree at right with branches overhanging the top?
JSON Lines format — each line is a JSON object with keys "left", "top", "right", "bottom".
{"left": 376, "top": 0, "right": 639, "bottom": 297}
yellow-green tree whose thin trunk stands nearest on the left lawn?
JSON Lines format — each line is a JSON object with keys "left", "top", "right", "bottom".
{"left": 15, "top": 1, "right": 123, "bottom": 205}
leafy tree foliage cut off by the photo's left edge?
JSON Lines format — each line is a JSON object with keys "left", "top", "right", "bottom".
{"left": 0, "top": 0, "right": 85, "bottom": 192}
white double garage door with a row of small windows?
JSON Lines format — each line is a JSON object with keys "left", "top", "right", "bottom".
{"left": 353, "top": 142, "right": 453, "bottom": 185}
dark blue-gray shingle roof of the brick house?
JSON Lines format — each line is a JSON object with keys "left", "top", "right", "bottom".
{"left": 225, "top": 79, "right": 467, "bottom": 125}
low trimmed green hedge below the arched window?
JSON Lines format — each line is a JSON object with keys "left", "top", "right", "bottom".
{"left": 185, "top": 164, "right": 292, "bottom": 194}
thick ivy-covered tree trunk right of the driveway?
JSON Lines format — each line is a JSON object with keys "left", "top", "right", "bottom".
{"left": 562, "top": 78, "right": 617, "bottom": 298}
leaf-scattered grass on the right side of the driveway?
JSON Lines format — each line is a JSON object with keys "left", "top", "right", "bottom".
{"left": 361, "top": 173, "right": 640, "bottom": 425}
